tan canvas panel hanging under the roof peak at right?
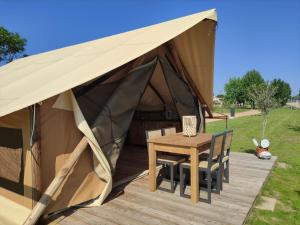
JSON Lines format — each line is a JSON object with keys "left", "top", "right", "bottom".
{"left": 172, "top": 20, "right": 217, "bottom": 109}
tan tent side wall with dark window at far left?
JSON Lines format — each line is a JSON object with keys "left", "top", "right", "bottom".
{"left": 0, "top": 109, "right": 35, "bottom": 209}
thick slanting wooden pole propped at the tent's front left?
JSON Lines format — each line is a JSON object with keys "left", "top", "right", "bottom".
{"left": 24, "top": 137, "right": 88, "bottom": 225}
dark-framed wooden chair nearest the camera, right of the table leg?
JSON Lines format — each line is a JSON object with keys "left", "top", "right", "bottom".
{"left": 179, "top": 133, "right": 225, "bottom": 203}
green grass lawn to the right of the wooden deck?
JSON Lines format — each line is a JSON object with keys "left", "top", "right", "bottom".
{"left": 207, "top": 108, "right": 300, "bottom": 225}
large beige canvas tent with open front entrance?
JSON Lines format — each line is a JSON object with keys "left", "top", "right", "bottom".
{"left": 0, "top": 10, "right": 217, "bottom": 224}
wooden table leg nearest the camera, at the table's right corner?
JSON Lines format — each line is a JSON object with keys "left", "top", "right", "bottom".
{"left": 191, "top": 148, "right": 199, "bottom": 203}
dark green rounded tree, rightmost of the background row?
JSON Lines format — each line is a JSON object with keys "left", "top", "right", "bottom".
{"left": 271, "top": 79, "right": 292, "bottom": 106}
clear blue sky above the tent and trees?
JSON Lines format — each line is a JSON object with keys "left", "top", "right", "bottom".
{"left": 0, "top": 0, "right": 300, "bottom": 94}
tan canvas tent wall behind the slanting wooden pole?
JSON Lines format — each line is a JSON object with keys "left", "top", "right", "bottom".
{"left": 40, "top": 96, "right": 105, "bottom": 213}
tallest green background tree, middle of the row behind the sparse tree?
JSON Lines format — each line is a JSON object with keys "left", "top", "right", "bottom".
{"left": 242, "top": 70, "right": 265, "bottom": 108}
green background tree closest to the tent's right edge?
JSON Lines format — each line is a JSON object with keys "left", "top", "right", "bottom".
{"left": 224, "top": 77, "right": 245, "bottom": 104}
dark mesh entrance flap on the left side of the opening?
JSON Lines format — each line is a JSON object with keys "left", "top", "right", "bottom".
{"left": 77, "top": 58, "right": 157, "bottom": 171}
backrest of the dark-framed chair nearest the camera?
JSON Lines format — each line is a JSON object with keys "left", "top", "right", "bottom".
{"left": 208, "top": 132, "right": 225, "bottom": 165}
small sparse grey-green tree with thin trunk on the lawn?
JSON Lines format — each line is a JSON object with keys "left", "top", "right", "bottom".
{"left": 249, "top": 83, "right": 277, "bottom": 139}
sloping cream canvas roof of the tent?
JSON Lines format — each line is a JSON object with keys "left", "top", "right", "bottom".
{"left": 0, "top": 9, "right": 217, "bottom": 116}
